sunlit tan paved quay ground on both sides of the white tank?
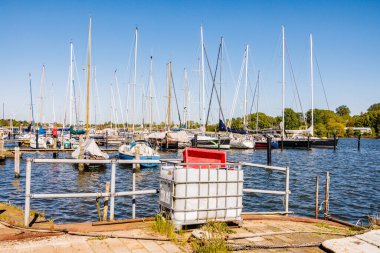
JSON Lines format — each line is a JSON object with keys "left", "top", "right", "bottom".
{"left": 0, "top": 211, "right": 368, "bottom": 253}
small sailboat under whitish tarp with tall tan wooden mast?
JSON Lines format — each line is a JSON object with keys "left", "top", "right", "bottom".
{"left": 71, "top": 17, "right": 109, "bottom": 168}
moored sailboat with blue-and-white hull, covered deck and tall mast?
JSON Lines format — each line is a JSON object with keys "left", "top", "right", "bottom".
{"left": 118, "top": 28, "right": 160, "bottom": 167}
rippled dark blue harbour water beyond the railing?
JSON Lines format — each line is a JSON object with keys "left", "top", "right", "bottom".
{"left": 0, "top": 139, "right": 380, "bottom": 223}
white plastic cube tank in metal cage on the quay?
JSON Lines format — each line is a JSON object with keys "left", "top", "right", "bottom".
{"left": 160, "top": 165, "right": 243, "bottom": 226}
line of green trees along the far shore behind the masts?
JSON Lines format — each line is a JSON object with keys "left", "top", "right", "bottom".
{"left": 0, "top": 103, "right": 380, "bottom": 137}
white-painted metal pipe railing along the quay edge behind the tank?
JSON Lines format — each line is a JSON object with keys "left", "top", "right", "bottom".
{"left": 24, "top": 158, "right": 291, "bottom": 226}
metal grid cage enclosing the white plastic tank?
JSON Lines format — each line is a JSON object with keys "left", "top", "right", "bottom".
{"left": 159, "top": 162, "right": 244, "bottom": 230}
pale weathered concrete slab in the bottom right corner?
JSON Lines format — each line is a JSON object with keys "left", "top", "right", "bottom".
{"left": 322, "top": 230, "right": 380, "bottom": 253}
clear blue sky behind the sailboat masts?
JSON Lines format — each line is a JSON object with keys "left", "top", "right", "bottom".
{"left": 0, "top": 0, "right": 380, "bottom": 122}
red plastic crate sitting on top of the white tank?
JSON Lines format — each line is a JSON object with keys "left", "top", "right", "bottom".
{"left": 183, "top": 148, "right": 227, "bottom": 169}
